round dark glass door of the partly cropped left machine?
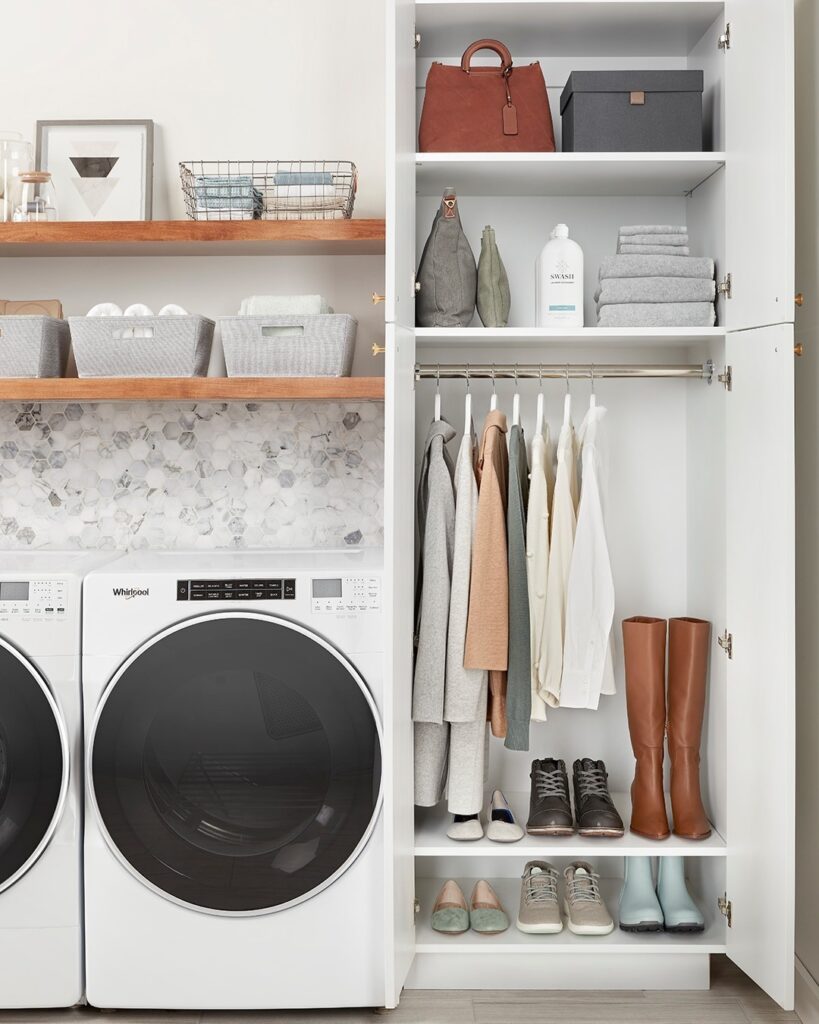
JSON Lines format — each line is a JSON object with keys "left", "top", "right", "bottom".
{"left": 0, "top": 640, "right": 69, "bottom": 890}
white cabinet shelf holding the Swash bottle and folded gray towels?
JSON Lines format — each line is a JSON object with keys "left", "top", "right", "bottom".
{"left": 416, "top": 327, "right": 725, "bottom": 352}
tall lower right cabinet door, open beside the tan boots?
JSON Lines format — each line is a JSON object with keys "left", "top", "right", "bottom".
{"left": 728, "top": 326, "right": 795, "bottom": 1010}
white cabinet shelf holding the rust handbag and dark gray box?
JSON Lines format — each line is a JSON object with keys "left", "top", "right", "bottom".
{"left": 416, "top": 153, "right": 725, "bottom": 196}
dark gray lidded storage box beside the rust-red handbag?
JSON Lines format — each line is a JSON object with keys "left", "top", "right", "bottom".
{"left": 560, "top": 71, "right": 702, "bottom": 153}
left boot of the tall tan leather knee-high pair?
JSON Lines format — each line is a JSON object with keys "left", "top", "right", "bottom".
{"left": 622, "top": 615, "right": 671, "bottom": 839}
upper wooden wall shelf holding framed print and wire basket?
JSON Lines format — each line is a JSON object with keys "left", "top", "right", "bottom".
{"left": 0, "top": 218, "right": 385, "bottom": 256}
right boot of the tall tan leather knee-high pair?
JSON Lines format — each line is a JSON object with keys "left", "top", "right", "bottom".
{"left": 667, "top": 618, "right": 710, "bottom": 839}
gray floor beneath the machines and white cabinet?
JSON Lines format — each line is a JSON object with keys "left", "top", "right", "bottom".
{"left": 0, "top": 956, "right": 799, "bottom": 1024}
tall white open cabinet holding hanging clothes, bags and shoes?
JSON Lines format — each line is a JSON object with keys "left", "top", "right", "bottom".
{"left": 385, "top": 0, "right": 794, "bottom": 1007}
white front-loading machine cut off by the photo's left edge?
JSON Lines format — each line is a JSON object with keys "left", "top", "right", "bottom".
{"left": 0, "top": 551, "right": 118, "bottom": 1009}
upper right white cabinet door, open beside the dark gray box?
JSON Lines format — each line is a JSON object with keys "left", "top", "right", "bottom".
{"left": 719, "top": 0, "right": 795, "bottom": 331}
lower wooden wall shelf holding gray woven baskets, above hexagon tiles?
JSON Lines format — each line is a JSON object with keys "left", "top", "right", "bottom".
{"left": 0, "top": 377, "right": 384, "bottom": 402}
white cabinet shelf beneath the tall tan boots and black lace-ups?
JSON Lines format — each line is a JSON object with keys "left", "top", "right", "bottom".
{"left": 416, "top": 793, "right": 728, "bottom": 861}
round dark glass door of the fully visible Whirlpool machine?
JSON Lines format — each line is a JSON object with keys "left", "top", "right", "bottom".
{"left": 88, "top": 612, "right": 381, "bottom": 913}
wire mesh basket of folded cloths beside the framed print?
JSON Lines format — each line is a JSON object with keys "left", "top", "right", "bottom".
{"left": 179, "top": 160, "right": 357, "bottom": 220}
